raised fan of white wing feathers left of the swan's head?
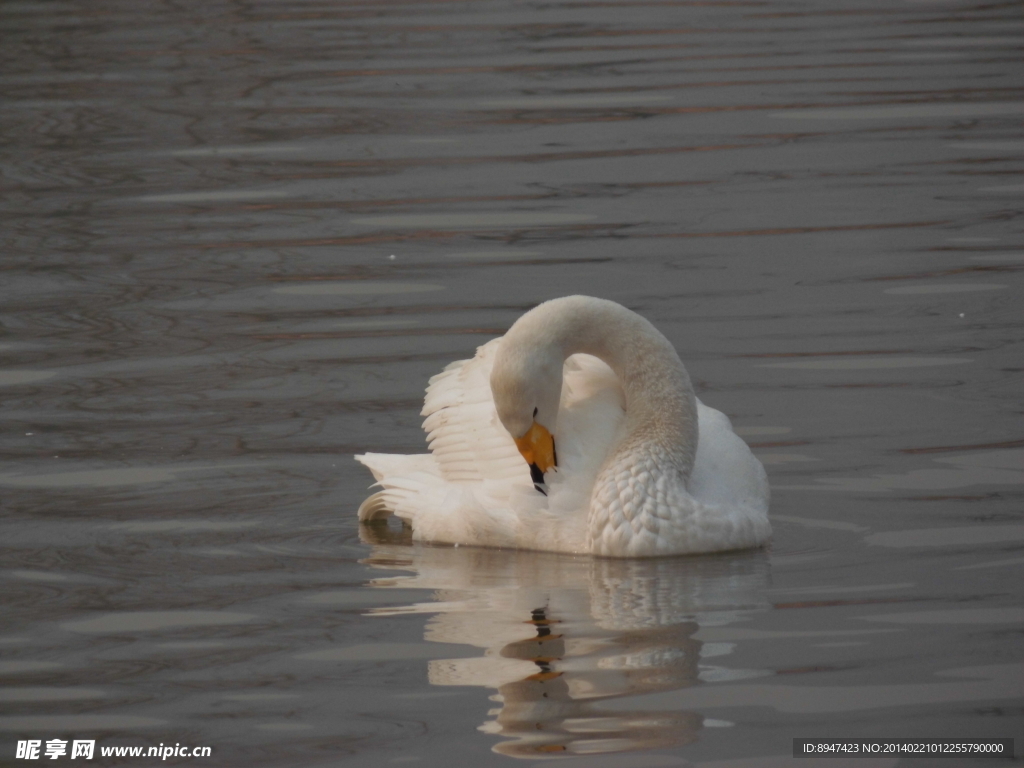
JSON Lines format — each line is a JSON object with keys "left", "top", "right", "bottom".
{"left": 421, "top": 339, "right": 531, "bottom": 484}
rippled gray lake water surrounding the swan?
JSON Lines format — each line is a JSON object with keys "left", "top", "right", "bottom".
{"left": 0, "top": 0, "right": 1024, "bottom": 768}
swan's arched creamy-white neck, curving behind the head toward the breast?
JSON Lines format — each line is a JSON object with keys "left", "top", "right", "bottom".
{"left": 506, "top": 296, "right": 697, "bottom": 477}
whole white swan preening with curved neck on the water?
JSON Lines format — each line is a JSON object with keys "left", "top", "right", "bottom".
{"left": 355, "top": 296, "right": 771, "bottom": 557}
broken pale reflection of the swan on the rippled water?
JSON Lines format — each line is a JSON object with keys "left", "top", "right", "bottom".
{"left": 362, "top": 525, "right": 769, "bottom": 759}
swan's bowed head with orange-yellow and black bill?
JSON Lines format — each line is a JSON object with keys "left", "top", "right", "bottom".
{"left": 490, "top": 342, "right": 562, "bottom": 485}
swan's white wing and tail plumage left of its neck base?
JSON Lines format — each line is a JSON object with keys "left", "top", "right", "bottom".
{"left": 357, "top": 348, "right": 625, "bottom": 552}
